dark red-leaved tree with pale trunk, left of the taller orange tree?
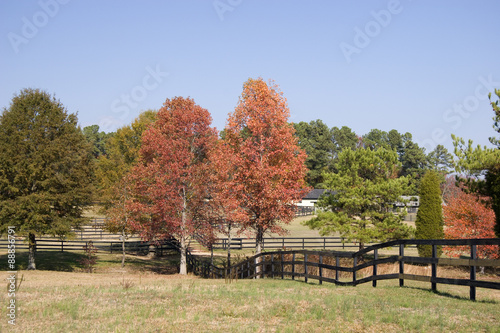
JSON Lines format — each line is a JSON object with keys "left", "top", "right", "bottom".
{"left": 128, "top": 97, "right": 217, "bottom": 274}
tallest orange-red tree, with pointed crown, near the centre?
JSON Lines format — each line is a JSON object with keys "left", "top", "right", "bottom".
{"left": 223, "top": 78, "right": 309, "bottom": 254}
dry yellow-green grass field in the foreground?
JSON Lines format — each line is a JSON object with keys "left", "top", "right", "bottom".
{"left": 0, "top": 252, "right": 500, "bottom": 332}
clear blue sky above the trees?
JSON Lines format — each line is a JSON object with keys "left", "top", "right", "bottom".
{"left": 0, "top": 0, "right": 500, "bottom": 152}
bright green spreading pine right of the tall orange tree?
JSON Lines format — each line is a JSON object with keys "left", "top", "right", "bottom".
{"left": 306, "top": 148, "right": 412, "bottom": 249}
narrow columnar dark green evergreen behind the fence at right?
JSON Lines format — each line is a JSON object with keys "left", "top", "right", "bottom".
{"left": 415, "top": 170, "right": 444, "bottom": 257}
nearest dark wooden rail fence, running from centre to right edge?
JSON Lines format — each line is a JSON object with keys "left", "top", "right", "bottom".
{"left": 188, "top": 238, "right": 500, "bottom": 300}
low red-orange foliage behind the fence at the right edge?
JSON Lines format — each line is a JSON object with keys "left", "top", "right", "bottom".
{"left": 443, "top": 185, "right": 499, "bottom": 259}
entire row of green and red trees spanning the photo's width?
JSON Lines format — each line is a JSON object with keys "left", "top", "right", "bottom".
{"left": 0, "top": 82, "right": 500, "bottom": 274}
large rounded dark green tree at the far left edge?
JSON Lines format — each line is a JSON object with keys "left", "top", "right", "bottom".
{"left": 0, "top": 89, "right": 93, "bottom": 269}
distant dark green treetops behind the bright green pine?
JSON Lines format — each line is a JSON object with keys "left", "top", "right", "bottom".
{"left": 294, "top": 119, "right": 453, "bottom": 195}
